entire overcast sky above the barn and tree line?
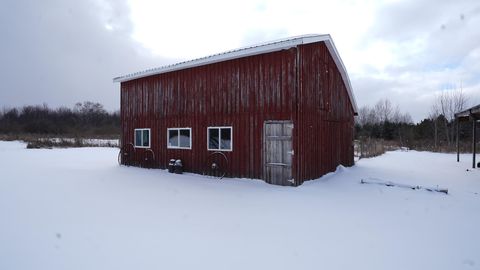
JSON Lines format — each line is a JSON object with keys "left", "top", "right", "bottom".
{"left": 0, "top": 0, "right": 480, "bottom": 121}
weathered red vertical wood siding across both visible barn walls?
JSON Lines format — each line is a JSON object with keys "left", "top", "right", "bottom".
{"left": 121, "top": 42, "right": 353, "bottom": 184}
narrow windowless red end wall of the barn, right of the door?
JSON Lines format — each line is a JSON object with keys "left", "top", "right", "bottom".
{"left": 294, "top": 43, "right": 354, "bottom": 186}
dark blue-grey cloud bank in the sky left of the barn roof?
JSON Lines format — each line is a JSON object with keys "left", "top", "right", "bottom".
{"left": 0, "top": 0, "right": 171, "bottom": 110}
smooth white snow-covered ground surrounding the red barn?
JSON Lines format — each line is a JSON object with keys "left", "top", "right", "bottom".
{"left": 0, "top": 142, "right": 480, "bottom": 270}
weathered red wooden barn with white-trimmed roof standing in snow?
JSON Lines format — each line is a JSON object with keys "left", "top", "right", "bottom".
{"left": 114, "top": 35, "right": 357, "bottom": 186}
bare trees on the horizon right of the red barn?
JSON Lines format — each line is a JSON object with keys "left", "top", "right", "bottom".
{"left": 355, "top": 90, "right": 472, "bottom": 152}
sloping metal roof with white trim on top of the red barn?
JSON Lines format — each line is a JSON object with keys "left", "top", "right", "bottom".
{"left": 113, "top": 34, "right": 358, "bottom": 114}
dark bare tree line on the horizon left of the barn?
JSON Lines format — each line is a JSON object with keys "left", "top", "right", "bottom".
{"left": 0, "top": 101, "right": 120, "bottom": 137}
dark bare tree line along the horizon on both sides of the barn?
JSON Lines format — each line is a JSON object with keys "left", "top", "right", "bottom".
{"left": 0, "top": 90, "right": 471, "bottom": 151}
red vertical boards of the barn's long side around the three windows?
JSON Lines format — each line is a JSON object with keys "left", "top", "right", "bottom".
{"left": 121, "top": 48, "right": 296, "bottom": 178}
